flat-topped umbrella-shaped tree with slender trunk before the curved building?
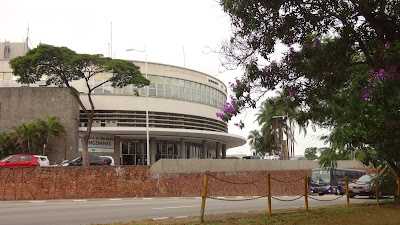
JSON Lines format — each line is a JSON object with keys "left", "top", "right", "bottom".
{"left": 10, "top": 44, "right": 150, "bottom": 166}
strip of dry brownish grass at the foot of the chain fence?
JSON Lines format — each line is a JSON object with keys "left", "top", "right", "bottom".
{"left": 96, "top": 202, "right": 400, "bottom": 225}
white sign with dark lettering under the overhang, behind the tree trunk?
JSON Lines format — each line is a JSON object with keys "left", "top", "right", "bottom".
{"left": 79, "top": 132, "right": 114, "bottom": 153}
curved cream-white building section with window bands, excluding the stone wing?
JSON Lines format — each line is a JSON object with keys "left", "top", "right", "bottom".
{"left": 74, "top": 61, "right": 246, "bottom": 165}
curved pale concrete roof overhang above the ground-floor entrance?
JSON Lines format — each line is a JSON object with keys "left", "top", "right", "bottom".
{"left": 79, "top": 127, "right": 247, "bottom": 149}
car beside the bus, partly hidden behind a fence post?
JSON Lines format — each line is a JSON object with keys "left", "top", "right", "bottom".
{"left": 349, "top": 174, "right": 396, "bottom": 198}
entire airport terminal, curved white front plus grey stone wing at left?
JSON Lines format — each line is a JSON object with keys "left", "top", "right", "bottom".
{"left": 0, "top": 42, "right": 246, "bottom": 165}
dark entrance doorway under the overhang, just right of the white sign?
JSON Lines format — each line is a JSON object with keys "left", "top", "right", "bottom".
{"left": 121, "top": 140, "right": 147, "bottom": 165}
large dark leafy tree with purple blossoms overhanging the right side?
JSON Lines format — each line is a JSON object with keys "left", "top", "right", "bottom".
{"left": 219, "top": 0, "right": 400, "bottom": 177}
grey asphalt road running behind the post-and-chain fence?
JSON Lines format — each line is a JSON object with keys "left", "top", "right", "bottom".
{"left": 0, "top": 195, "right": 374, "bottom": 225}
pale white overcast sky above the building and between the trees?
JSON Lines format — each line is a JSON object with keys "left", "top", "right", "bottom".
{"left": 0, "top": 0, "right": 324, "bottom": 155}
